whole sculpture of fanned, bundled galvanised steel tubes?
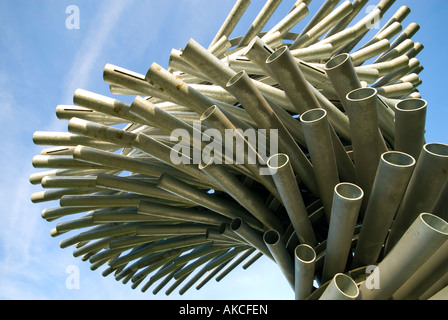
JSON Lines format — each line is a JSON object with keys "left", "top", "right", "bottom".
{"left": 30, "top": 0, "right": 448, "bottom": 300}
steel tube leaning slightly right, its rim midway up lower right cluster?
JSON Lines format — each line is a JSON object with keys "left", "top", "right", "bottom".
{"left": 322, "top": 182, "right": 364, "bottom": 282}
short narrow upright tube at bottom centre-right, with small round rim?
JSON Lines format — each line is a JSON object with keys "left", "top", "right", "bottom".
{"left": 294, "top": 244, "right": 316, "bottom": 300}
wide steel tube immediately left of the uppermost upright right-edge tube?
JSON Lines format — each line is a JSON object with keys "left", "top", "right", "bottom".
{"left": 346, "top": 88, "right": 387, "bottom": 203}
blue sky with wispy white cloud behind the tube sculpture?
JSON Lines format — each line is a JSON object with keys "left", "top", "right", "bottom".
{"left": 0, "top": 0, "right": 448, "bottom": 299}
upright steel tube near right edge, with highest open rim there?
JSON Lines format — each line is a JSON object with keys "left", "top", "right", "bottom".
{"left": 395, "top": 98, "right": 427, "bottom": 160}
